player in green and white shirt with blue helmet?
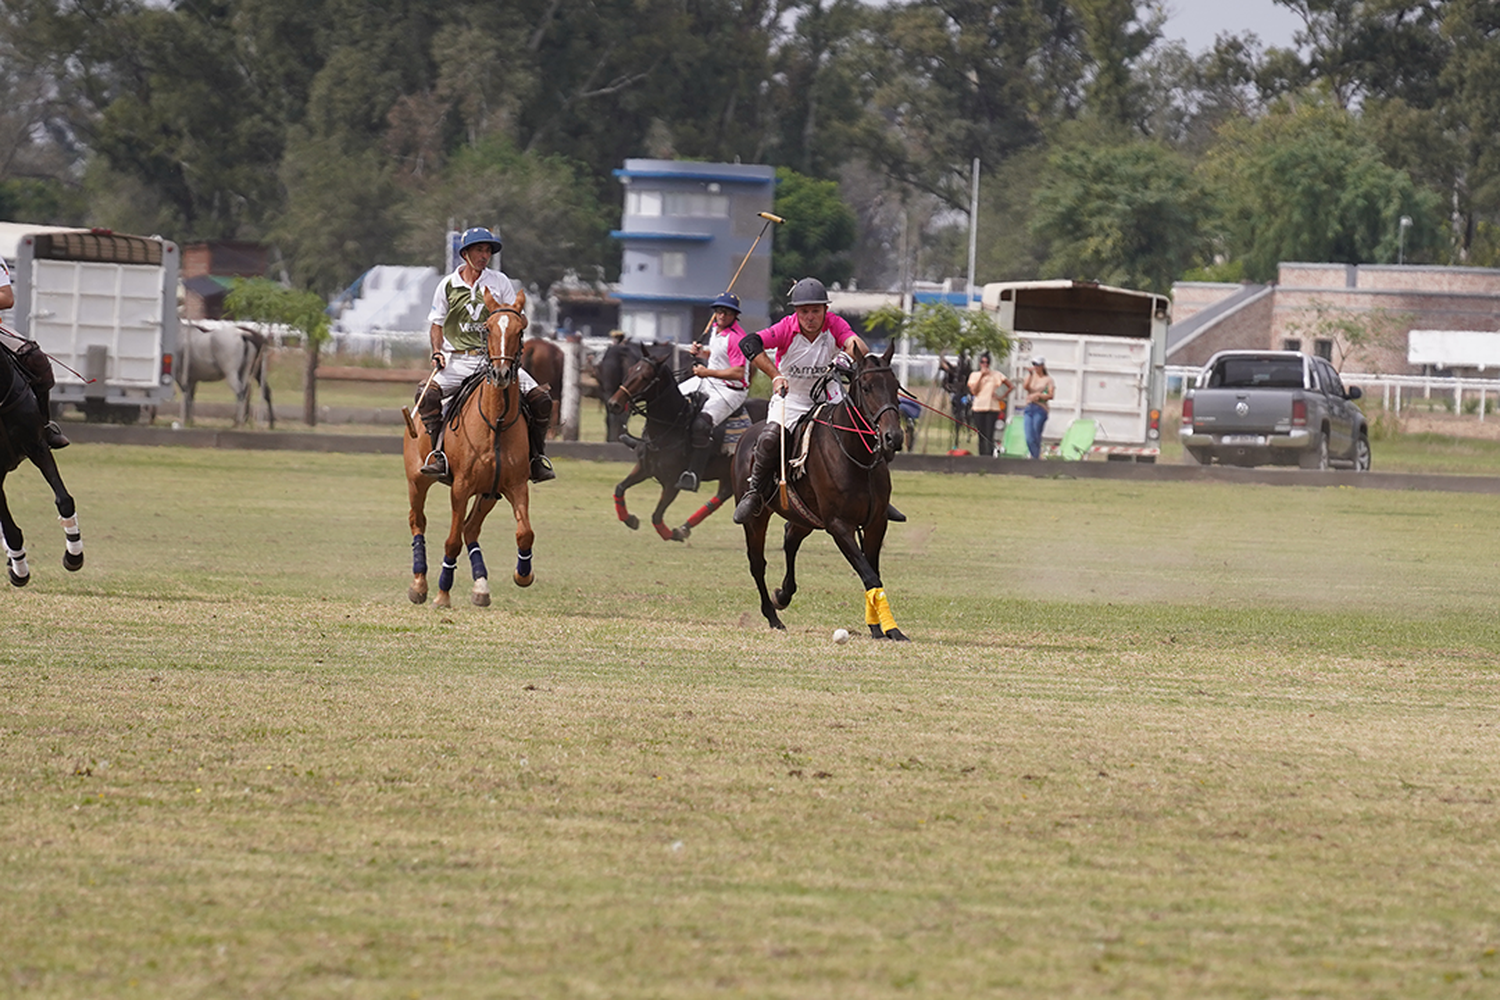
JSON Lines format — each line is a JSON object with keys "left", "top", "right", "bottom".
{"left": 417, "top": 226, "right": 557, "bottom": 483}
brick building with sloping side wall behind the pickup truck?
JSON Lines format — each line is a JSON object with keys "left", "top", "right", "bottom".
{"left": 1167, "top": 264, "right": 1500, "bottom": 375}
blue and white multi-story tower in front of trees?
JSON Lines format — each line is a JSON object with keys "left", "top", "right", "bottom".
{"left": 611, "top": 159, "right": 776, "bottom": 343}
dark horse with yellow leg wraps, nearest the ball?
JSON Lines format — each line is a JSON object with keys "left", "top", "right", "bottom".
{"left": 734, "top": 342, "right": 906, "bottom": 640}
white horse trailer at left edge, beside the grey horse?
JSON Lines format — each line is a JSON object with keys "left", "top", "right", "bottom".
{"left": 0, "top": 222, "right": 179, "bottom": 423}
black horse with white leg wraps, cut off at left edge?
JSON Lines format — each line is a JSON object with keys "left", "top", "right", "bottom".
{"left": 0, "top": 348, "right": 84, "bottom": 586}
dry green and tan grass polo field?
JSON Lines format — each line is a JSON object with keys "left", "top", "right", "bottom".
{"left": 0, "top": 445, "right": 1500, "bottom": 999}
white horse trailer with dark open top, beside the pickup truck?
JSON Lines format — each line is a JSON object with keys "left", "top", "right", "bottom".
{"left": 983, "top": 280, "right": 1172, "bottom": 462}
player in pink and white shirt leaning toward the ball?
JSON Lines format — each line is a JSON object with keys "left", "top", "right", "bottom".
{"left": 734, "top": 277, "right": 906, "bottom": 525}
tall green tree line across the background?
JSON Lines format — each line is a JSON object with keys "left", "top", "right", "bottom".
{"left": 0, "top": 0, "right": 1500, "bottom": 297}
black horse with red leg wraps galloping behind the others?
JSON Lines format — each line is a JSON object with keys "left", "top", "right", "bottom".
{"left": 608, "top": 348, "right": 767, "bottom": 541}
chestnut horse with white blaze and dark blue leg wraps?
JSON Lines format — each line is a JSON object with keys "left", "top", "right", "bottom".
{"left": 402, "top": 288, "right": 536, "bottom": 607}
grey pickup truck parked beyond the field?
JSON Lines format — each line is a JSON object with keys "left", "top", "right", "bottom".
{"left": 1182, "top": 351, "right": 1370, "bottom": 472}
